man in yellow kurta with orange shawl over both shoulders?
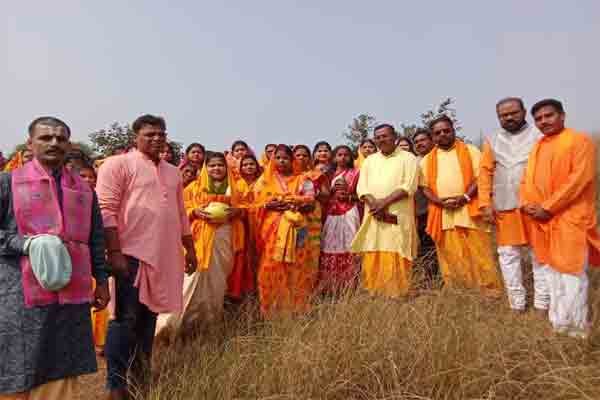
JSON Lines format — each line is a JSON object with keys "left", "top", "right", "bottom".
{"left": 421, "top": 116, "right": 501, "bottom": 295}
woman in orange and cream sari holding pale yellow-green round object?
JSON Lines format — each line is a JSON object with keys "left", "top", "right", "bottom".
{"left": 157, "top": 153, "right": 244, "bottom": 339}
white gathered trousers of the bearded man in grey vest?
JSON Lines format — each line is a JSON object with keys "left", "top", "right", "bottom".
{"left": 498, "top": 246, "right": 550, "bottom": 310}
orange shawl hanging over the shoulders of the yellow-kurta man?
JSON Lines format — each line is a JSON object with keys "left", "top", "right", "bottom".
{"left": 426, "top": 140, "right": 480, "bottom": 242}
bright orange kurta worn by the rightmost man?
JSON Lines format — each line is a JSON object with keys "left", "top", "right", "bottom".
{"left": 521, "top": 129, "right": 600, "bottom": 274}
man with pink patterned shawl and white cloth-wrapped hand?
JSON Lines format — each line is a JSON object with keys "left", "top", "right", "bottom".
{"left": 0, "top": 117, "right": 109, "bottom": 400}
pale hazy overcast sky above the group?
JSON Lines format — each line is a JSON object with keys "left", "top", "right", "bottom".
{"left": 0, "top": 0, "right": 600, "bottom": 151}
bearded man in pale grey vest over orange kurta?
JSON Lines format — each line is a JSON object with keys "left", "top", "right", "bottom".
{"left": 478, "top": 97, "right": 549, "bottom": 315}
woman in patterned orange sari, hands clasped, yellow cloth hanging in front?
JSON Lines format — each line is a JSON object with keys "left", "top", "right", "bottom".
{"left": 254, "top": 145, "right": 315, "bottom": 316}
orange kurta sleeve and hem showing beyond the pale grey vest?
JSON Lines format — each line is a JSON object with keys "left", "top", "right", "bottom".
{"left": 477, "top": 142, "right": 527, "bottom": 246}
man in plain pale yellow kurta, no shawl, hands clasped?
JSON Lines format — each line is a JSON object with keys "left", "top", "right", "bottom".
{"left": 352, "top": 124, "right": 418, "bottom": 297}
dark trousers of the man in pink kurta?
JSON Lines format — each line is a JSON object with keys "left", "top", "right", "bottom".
{"left": 104, "top": 257, "right": 156, "bottom": 390}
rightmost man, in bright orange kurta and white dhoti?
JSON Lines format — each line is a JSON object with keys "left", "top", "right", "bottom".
{"left": 521, "top": 99, "right": 600, "bottom": 337}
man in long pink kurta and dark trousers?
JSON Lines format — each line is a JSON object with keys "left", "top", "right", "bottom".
{"left": 96, "top": 115, "right": 196, "bottom": 399}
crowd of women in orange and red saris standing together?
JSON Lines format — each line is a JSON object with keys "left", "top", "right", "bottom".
{"left": 158, "top": 139, "right": 390, "bottom": 331}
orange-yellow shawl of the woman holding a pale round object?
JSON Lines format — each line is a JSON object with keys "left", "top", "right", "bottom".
{"left": 183, "top": 165, "right": 244, "bottom": 270}
